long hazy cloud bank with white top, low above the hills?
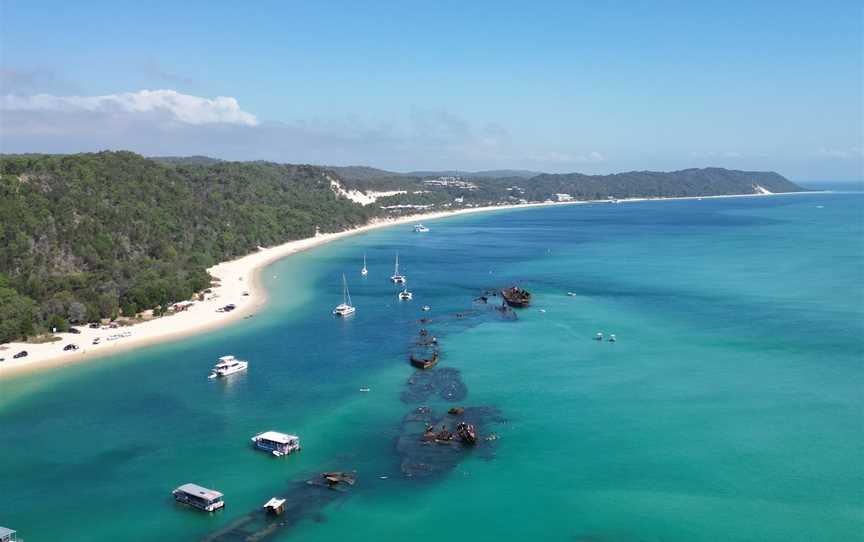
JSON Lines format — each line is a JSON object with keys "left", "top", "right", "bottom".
{"left": 0, "top": 90, "right": 606, "bottom": 171}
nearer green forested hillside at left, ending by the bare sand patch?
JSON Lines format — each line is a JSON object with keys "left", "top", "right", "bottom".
{"left": 0, "top": 152, "right": 376, "bottom": 343}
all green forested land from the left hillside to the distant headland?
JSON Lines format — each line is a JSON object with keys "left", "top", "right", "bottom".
{"left": 0, "top": 152, "right": 800, "bottom": 343}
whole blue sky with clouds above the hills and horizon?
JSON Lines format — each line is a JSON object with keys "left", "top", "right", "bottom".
{"left": 0, "top": 0, "right": 864, "bottom": 181}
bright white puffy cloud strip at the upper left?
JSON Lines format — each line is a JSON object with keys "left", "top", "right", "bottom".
{"left": 0, "top": 90, "right": 258, "bottom": 126}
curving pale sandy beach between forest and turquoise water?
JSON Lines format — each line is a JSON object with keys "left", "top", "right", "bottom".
{"left": 0, "top": 191, "right": 825, "bottom": 381}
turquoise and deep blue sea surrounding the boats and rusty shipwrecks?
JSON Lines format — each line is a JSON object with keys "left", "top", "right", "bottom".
{"left": 0, "top": 193, "right": 864, "bottom": 542}
